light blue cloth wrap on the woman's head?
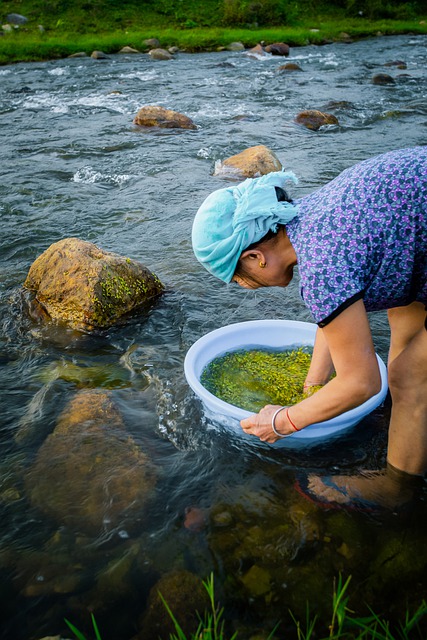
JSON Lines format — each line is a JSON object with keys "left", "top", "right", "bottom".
{"left": 192, "top": 171, "right": 298, "bottom": 282}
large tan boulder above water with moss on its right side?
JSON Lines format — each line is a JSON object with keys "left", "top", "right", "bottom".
{"left": 24, "top": 238, "right": 164, "bottom": 331}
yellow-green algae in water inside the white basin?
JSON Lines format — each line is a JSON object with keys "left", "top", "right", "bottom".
{"left": 200, "top": 347, "right": 313, "bottom": 412}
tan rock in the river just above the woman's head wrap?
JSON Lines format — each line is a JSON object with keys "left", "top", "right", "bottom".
{"left": 214, "top": 144, "right": 282, "bottom": 180}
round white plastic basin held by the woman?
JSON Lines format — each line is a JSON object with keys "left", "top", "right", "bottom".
{"left": 184, "top": 320, "right": 387, "bottom": 447}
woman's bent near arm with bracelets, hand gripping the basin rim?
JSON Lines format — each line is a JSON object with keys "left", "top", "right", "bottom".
{"left": 240, "top": 300, "right": 381, "bottom": 443}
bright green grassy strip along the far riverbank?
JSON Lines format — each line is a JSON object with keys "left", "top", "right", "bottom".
{"left": 0, "top": 17, "right": 427, "bottom": 65}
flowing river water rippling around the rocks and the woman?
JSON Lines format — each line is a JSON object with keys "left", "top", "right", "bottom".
{"left": 0, "top": 35, "right": 427, "bottom": 640}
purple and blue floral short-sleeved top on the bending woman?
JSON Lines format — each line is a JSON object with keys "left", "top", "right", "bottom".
{"left": 286, "top": 147, "right": 427, "bottom": 326}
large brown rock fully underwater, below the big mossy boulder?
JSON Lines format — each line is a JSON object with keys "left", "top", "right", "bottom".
{"left": 25, "top": 389, "right": 156, "bottom": 535}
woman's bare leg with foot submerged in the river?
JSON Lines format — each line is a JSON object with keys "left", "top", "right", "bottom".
{"left": 307, "top": 302, "right": 427, "bottom": 507}
